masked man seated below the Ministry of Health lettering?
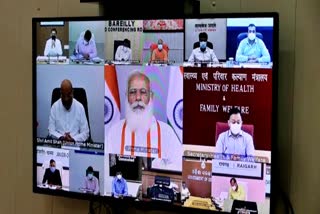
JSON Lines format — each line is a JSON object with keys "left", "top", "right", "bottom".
{"left": 215, "top": 108, "right": 254, "bottom": 160}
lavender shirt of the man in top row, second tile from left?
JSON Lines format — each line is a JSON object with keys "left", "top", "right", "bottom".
{"left": 75, "top": 37, "right": 97, "bottom": 59}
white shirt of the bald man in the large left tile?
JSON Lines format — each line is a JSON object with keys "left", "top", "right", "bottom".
{"left": 48, "top": 98, "right": 89, "bottom": 141}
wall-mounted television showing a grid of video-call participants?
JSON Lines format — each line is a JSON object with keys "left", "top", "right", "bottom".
{"left": 33, "top": 13, "right": 278, "bottom": 214}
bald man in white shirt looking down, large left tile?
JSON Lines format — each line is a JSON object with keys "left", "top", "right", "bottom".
{"left": 48, "top": 79, "right": 89, "bottom": 142}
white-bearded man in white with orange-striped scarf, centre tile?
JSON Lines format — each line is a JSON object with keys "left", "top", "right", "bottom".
{"left": 105, "top": 72, "right": 182, "bottom": 170}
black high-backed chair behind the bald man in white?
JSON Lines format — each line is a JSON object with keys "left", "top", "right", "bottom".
{"left": 51, "top": 88, "right": 92, "bottom": 142}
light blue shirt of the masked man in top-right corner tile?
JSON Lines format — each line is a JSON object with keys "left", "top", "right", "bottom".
{"left": 236, "top": 38, "right": 271, "bottom": 63}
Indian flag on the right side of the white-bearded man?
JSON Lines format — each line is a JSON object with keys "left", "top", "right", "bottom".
{"left": 167, "top": 66, "right": 183, "bottom": 143}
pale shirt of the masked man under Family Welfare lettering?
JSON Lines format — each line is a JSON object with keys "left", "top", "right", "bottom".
{"left": 215, "top": 130, "right": 254, "bottom": 157}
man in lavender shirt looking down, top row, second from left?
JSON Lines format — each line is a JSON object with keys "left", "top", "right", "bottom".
{"left": 74, "top": 30, "right": 97, "bottom": 60}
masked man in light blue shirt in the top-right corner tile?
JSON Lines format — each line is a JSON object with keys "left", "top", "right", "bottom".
{"left": 236, "top": 24, "right": 271, "bottom": 63}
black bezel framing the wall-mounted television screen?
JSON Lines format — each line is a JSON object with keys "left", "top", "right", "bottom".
{"left": 31, "top": 12, "right": 279, "bottom": 214}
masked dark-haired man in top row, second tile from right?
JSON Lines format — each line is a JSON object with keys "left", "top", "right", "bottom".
{"left": 188, "top": 32, "right": 219, "bottom": 63}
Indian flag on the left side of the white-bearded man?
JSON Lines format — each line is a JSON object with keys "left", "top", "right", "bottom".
{"left": 104, "top": 65, "right": 120, "bottom": 131}
